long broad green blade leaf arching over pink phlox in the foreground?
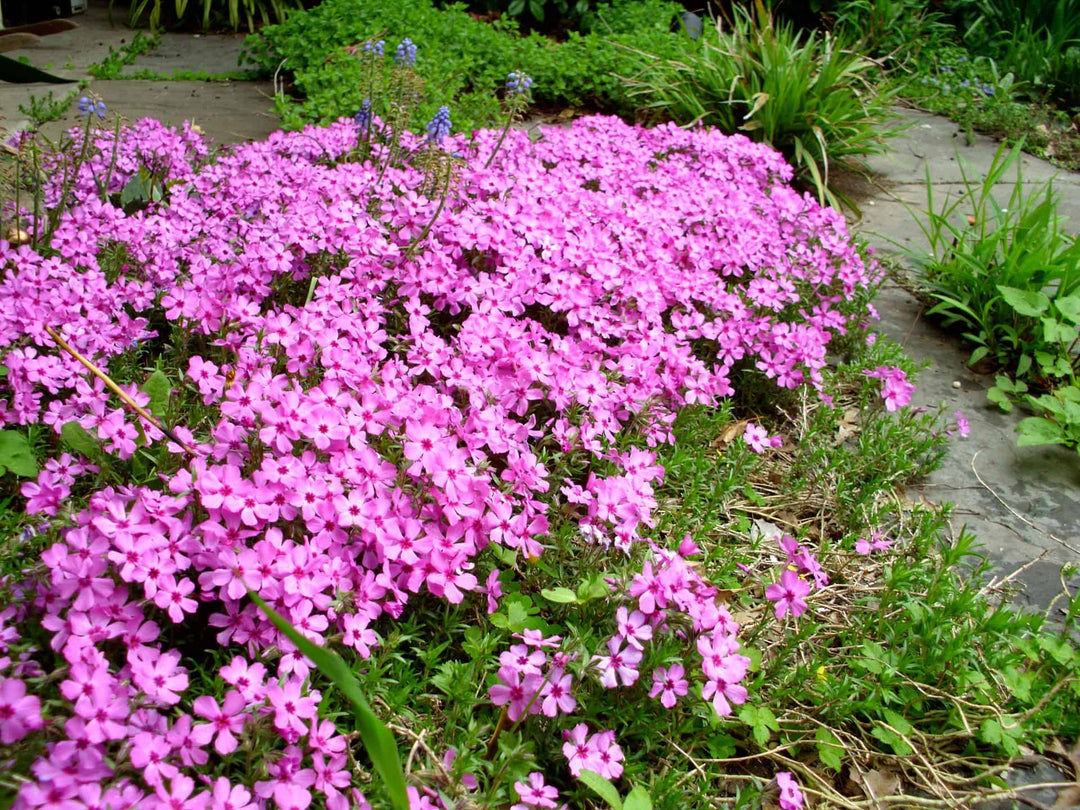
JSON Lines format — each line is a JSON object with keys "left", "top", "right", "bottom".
{"left": 247, "top": 591, "right": 409, "bottom": 810}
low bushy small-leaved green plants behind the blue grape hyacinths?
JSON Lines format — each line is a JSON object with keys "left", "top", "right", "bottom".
{"left": 241, "top": 0, "right": 686, "bottom": 133}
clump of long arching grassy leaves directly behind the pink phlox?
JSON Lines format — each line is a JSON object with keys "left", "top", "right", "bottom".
{"left": 632, "top": 2, "right": 896, "bottom": 204}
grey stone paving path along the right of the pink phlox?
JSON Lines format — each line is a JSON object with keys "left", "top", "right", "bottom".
{"left": 852, "top": 111, "right": 1080, "bottom": 608}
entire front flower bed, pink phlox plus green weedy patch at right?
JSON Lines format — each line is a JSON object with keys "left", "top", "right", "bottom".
{"left": 0, "top": 63, "right": 1080, "bottom": 810}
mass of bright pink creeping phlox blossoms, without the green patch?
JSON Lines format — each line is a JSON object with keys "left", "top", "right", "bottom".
{"left": 0, "top": 109, "right": 885, "bottom": 810}
